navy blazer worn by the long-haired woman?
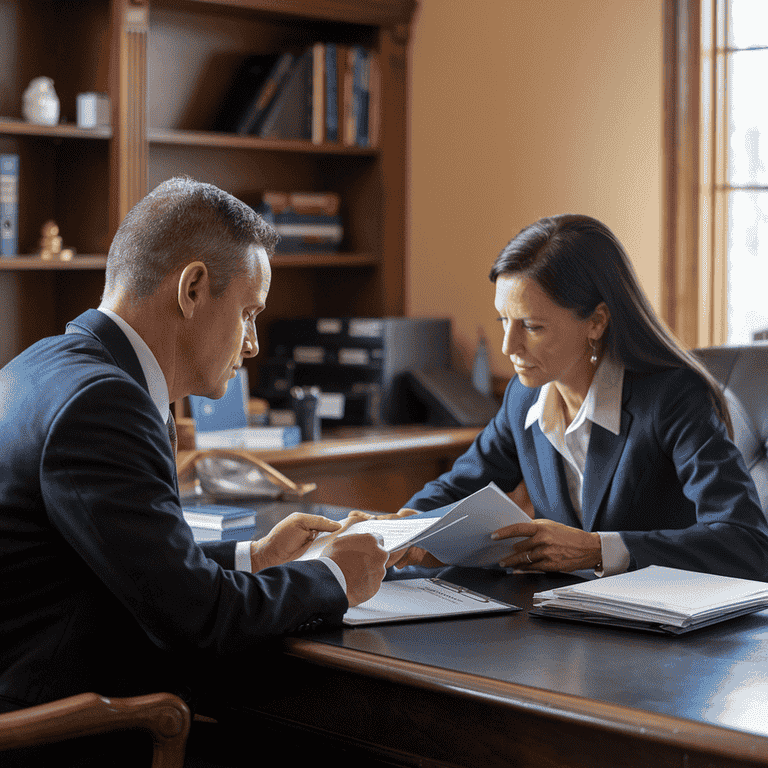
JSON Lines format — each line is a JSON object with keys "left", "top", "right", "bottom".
{"left": 404, "top": 369, "right": 768, "bottom": 579}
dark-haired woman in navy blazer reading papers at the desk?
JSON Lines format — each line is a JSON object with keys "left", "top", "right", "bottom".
{"left": 399, "top": 215, "right": 768, "bottom": 579}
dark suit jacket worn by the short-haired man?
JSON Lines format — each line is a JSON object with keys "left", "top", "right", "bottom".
{"left": 0, "top": 310, "right": 348, "bottom": 709}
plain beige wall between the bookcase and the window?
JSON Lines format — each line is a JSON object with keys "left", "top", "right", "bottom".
{"left": 406, "top": 0, "right": 663, "bottom": 376}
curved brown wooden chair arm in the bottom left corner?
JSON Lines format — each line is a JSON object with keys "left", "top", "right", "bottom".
{"left": 0, "top": 693, "right": 190, "bottom": 768}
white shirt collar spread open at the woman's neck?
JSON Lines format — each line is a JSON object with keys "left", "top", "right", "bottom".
{"left": 525, "top": 355, "right": 624, "bottom": 435}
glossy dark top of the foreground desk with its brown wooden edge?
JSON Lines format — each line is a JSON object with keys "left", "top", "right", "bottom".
{"left": 280, "top": 568, "right": 768, "bottom": 766}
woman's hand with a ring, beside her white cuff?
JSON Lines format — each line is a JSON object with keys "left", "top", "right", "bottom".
{"left": 491, "top": 518, "right": 602, "bottom": 572}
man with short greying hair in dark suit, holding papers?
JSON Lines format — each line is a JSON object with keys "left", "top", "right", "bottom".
{"left": 0, "top": 179, "right": 387, "bottom": 748}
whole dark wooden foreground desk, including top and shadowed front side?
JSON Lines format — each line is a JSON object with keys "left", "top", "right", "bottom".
{"left": 243, "top": 568, "right": 768, "bottom": 768}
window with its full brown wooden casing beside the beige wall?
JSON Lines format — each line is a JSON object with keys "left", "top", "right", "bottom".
{"left": 663, "top": 0, "right": 768, "bottom": 347}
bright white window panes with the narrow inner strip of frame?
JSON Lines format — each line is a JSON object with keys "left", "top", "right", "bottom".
{"left": 701, "top": 0, "right": 768, "bottom": 344}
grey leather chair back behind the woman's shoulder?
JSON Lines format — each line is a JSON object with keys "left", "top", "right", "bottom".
{"left": 694, "top": 342, "right": 768, "bottom": 517}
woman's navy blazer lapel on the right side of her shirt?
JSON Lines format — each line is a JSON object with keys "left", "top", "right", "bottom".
{"left": 581, "top": 371, "right": 632, "bottom": 531}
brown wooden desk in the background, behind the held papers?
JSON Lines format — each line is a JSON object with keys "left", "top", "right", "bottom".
{"left": 178, "top": 425, "right": 480, "bottom": 512}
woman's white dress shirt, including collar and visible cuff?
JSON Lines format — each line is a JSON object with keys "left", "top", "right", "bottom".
{"left": 525, "top": 355, "right": 630, "bottom": 576}
